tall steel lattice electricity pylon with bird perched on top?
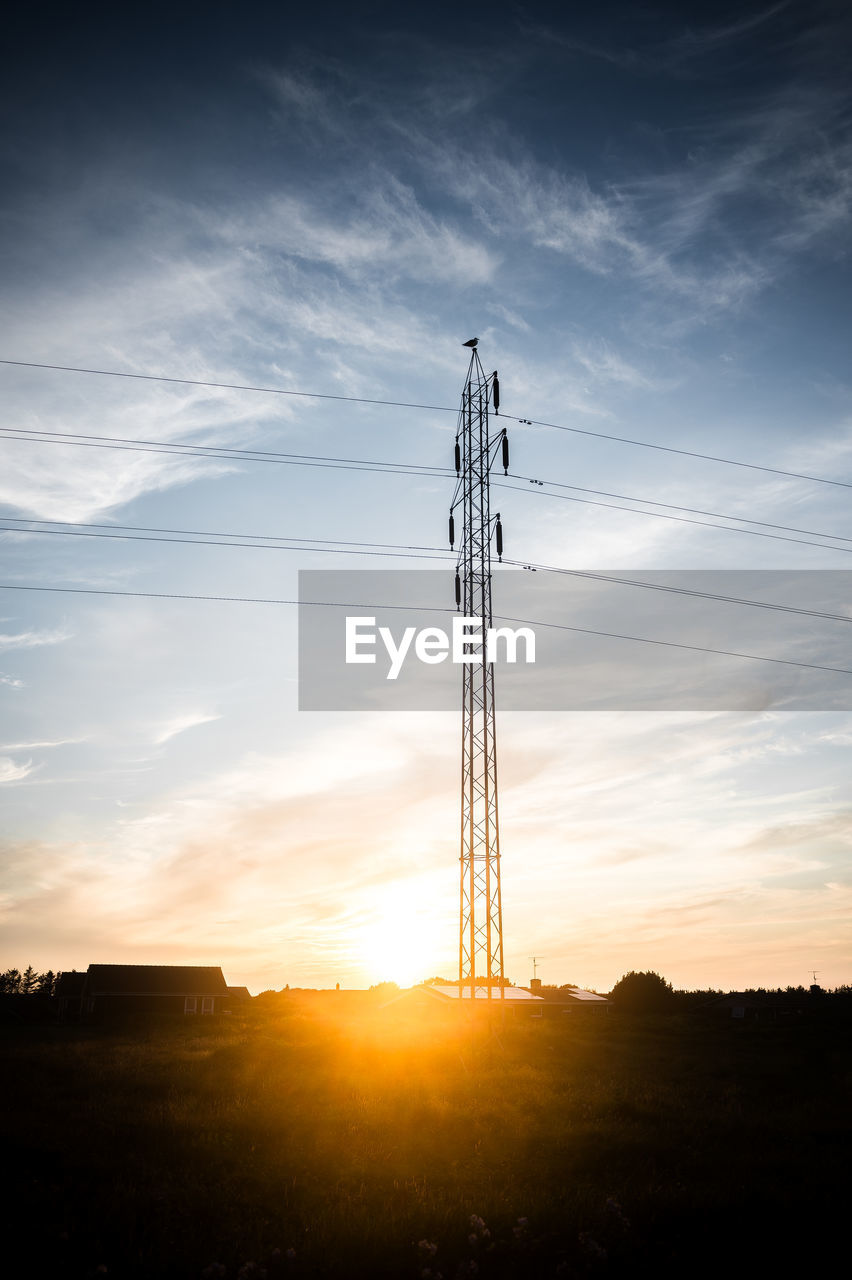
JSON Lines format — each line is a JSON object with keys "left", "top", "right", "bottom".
{"left": 449, "top": 339, "right": 509, "bottom": 1000}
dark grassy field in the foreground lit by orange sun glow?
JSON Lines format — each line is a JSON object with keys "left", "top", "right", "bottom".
{"left": 0, "top": 996, "right": 852, "bottom": 1280}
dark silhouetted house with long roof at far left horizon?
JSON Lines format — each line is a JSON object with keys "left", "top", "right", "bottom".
{"left": 60, "top": 964, "right": 232, "bottom": 1020}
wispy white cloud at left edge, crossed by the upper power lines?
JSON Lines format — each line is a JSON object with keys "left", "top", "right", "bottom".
{"left": 0, "top": 202, "right": 305, "bottom": 521}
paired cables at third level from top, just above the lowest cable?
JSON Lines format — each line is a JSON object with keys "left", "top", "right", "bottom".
{"left": 6, "top": 516, "right": 852, "bottom": 623}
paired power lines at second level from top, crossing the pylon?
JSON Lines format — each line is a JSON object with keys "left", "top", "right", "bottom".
{"left": 0, "top": 428, "right": 852, "bottom": 552}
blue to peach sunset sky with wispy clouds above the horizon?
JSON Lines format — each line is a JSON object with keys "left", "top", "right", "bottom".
{"left": 0, "top": 0, "right": 852, "bottom": 992}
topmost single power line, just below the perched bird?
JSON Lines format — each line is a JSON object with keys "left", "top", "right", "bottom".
{"left": 0, "top": 360, "right": 852, "bottom": 489}
